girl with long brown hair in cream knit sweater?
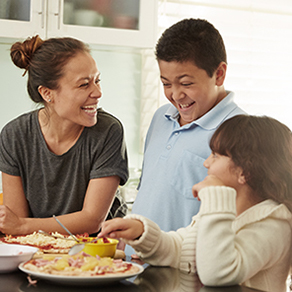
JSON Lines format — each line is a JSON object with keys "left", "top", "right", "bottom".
{"left": 99, "top": 115, "right": 292, "bottom": 292}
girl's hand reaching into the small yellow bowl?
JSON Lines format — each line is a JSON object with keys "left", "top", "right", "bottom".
{"left": 98, "top": 218, "right": 144, "bottom": 240}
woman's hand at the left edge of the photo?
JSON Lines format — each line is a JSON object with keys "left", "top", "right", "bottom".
{"left": 0, "top": 205, "right": 24, "bottom": 235}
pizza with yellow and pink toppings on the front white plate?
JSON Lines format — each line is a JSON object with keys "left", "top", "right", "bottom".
{"left": 23, "top": 252, "right": 140, "bottom": 277}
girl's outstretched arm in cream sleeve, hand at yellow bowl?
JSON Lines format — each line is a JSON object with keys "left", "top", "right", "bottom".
{"left": 98, "top": 214, "right": 195, "bottom": 273}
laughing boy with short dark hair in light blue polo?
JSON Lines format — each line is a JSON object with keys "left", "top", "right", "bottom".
{"left": 132, "top": 19, "right": 244, "bottom": 231}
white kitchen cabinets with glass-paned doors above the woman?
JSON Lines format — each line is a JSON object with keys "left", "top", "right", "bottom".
{"left": 0, "top": 0, "right": 158, "bottom": 48}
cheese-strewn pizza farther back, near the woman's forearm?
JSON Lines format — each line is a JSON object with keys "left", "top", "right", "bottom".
{"left": 0, "top": 232, "right": 82, "bottom": 254}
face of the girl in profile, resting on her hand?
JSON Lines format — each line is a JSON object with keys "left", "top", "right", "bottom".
{"left": 204, "top": 153, "right": 242, "bottom": 189}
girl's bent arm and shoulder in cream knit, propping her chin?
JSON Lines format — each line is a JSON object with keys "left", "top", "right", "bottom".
{"left": 196, "top": 187, "right": 291, "bottom": 291}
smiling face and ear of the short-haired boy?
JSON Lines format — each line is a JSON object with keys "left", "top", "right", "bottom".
{"left": 158, "top": 60, "right": 226, "bottom": 126}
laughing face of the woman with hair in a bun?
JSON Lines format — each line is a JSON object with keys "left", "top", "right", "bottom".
{"left": 53, "top": 53, "right": 102, "bottom": 127}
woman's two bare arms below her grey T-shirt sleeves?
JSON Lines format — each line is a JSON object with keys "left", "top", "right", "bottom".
{"left": 0, "top": 174, "right": 120, "bottom": 235}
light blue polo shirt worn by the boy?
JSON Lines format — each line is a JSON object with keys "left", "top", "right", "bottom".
{"left": 132, "top": 92, "right": 246, "bottom": 231}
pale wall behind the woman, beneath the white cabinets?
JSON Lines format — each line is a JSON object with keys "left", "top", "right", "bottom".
{"left": 0, "top": 39, "right": 142, "bottom": 168}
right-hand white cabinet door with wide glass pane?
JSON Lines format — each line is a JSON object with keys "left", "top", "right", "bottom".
{"left": 47, "top": 0, "right": 158, "bottom": 48}
